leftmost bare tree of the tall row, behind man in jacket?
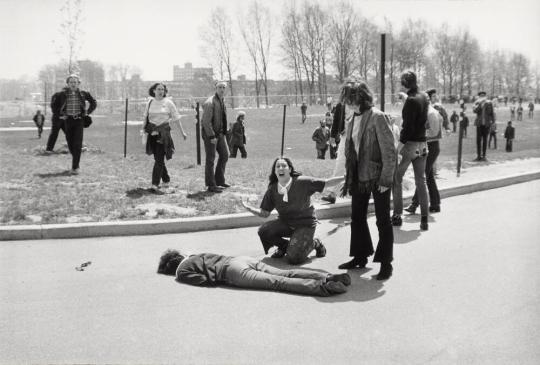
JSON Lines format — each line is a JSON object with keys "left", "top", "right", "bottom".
{"left": 200, "top": 7, "right": 234, "bottom": 108}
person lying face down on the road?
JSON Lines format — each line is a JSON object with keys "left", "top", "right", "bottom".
{"left": 157, "top": 249, "right": 351, "bottom": 297}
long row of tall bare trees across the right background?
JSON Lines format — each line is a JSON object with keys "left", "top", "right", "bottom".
{"left": 200, "top": 0, "right": 540, "bottom": 102}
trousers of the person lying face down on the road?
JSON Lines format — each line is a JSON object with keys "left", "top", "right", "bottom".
{"left": 225, "top": 256, "right": 330, "bottom": 297}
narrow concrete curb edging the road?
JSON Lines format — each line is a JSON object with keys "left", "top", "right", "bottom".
{"left": 0, "top": 171, "right": 540, "bottom": 241}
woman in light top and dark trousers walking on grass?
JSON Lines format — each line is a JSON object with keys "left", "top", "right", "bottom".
{"left": 143, "top": 83, "right": 187, "bottom": 195}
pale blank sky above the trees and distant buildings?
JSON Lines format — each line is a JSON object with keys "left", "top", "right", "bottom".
{"left": 0, "top": 0, "right": 540, "bottom": 80}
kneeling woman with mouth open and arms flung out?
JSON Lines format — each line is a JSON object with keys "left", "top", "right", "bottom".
{"left": 242, "top": 157, "right": 344, "bottom": 264}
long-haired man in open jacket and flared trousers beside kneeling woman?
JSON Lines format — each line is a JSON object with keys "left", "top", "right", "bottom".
{"left": 339, "top": 81, "right": 397, "bottom": 280}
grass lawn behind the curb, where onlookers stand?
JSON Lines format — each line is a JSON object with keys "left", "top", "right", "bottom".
{"left": 0, "top": 101, "right": 540, "bottom": 225}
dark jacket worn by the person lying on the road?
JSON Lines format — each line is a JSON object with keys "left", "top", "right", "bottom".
{"left": 176, "top": 253, "right": 232, "bottom": 286}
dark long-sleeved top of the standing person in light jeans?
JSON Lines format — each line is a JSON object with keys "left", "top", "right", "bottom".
{"left": 399, "top": 89, "right": 429, "bottom": 144}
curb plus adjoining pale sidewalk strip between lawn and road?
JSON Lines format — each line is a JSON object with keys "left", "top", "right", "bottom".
{"left": 0, "top": 158, "right": 540, "bottom": 241}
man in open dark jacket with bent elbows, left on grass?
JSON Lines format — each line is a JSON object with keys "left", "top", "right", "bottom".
{"left": 47, "top": 75, "right": 97, "bottom": 175}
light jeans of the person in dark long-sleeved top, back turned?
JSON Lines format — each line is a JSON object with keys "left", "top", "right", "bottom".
{"left": 392, "top": 142, "right": 429, "bottom": 216}
